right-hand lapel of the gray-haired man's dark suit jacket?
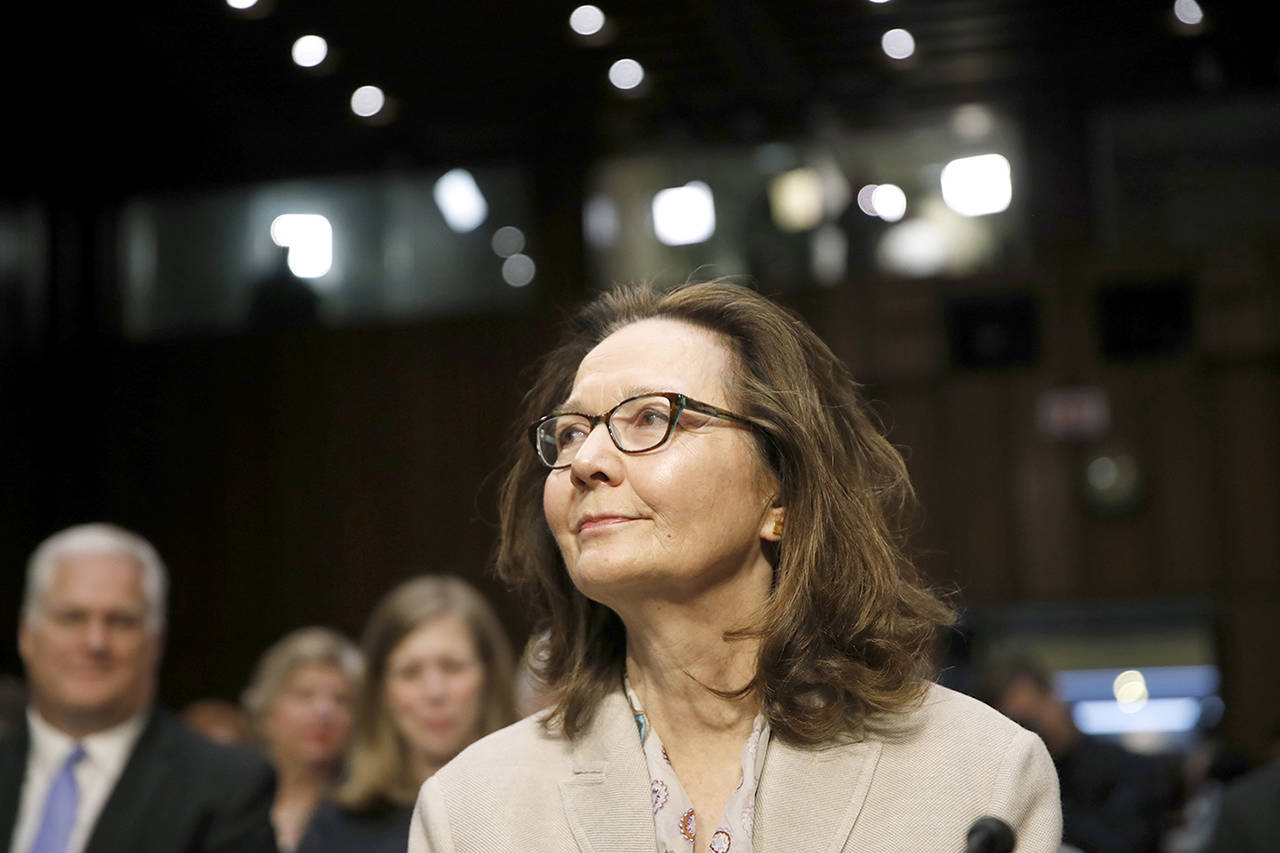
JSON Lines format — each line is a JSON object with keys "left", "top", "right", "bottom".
{"left": 84, "top": 710, "right": 178, "bottom": 853}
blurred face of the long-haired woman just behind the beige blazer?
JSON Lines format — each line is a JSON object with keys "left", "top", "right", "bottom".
{"left": 387, "top": 613, "right": 485, "bottom": 767}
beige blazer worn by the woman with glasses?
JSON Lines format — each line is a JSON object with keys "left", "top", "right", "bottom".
{"left": 408, "top": 685, "right": 1062, "bottom": 853}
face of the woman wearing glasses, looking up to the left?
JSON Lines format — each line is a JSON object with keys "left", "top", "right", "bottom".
{"left": 543, "top": 319, "right": 777, "bottom": 607}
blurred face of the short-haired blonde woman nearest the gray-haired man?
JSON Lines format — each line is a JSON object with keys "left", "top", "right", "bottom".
{"left": 265, "top": 663, "right": 355, "bottom": 768}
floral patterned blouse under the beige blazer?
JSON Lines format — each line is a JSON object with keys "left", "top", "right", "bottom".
{"left": 622, "top": 676, "right": 769, "bottom": 853}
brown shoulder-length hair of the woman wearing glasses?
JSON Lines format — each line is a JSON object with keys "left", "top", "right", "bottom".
{"left": 497, "top": 282, "right": 954, "bottom": 744}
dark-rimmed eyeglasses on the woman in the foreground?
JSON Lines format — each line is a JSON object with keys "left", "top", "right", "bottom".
{"left": 529, "top": 391, "right": 751, "bottom": 467}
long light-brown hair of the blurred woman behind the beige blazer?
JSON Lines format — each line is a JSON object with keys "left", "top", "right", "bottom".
{"left": 334, "top": 575, "right": 516, "bottom": 812}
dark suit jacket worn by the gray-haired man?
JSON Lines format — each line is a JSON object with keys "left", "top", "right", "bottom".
{"left": 0, "top": 710, "right": 275, "bottom": 853}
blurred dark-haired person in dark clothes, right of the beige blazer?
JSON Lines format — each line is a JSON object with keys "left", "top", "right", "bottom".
{"left": 982, "top": 654, "right": 1175, "bottom": 853}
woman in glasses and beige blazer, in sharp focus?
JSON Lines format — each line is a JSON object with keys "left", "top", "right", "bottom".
{"left": 410, "top": 283, "right": 1061, "bottom": 853}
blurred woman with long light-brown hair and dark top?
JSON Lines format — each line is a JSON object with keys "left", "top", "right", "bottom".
{"left": 298, "top": 576, "right": 516, "bottom": 853}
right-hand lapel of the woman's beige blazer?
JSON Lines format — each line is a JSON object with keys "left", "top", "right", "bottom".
{"left": 751, "top": 739, "right": 881, "bottom": 853}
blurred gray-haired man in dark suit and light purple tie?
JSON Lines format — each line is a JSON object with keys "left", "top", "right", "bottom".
{"left": 0, "top": 524, "right": 275, "bottom": 853}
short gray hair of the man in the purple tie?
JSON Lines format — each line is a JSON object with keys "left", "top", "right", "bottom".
{"left": 22, "top": 524, "right": 169, "bottom": 634}
